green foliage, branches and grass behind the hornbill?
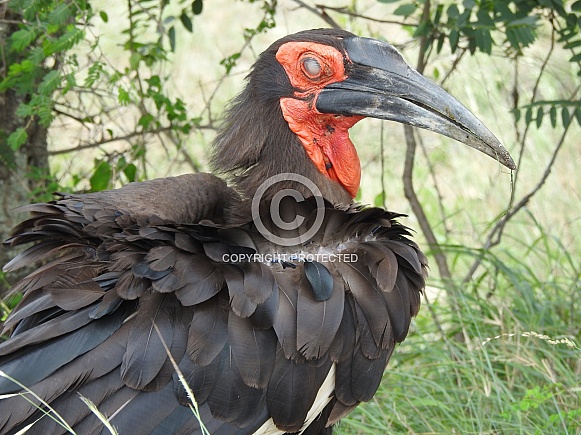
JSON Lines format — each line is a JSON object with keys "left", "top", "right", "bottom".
{"left": 0, "top": 0, "right": 581, "bottom": 434}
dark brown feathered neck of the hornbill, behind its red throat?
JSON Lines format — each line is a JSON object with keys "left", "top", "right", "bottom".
{"left": 212, "top": 92, "right": 352, "bottom": 220}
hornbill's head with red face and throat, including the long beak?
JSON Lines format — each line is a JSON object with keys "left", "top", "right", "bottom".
{"left": 215, "top": 29, "right": 515, "bottom": 203}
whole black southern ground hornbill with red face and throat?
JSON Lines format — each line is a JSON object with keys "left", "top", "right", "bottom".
{"left": 0, "top": 30, "right": 514, "bottom": 434}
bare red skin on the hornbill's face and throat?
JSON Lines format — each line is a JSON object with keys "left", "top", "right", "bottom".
{"left": 276, "top": 42, "right": 363, "bottom": 198}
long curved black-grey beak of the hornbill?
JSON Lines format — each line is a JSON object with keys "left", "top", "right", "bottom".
{"left": 316, "top": 37, "right": 516, "bottom": 169}
